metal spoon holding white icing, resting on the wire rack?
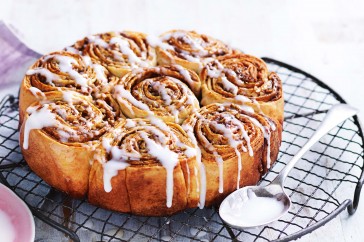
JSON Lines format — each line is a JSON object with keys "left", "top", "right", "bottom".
{"left": 219, "top": 104, "right": 358, "bottom": 229}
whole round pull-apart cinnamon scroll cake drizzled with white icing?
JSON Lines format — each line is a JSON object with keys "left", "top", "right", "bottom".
{"left": 19, "top": 30, "right": 284, "bottom": 216}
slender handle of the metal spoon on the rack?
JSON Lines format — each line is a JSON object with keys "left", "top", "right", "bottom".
{"left": 272, "top": 104, "right": 358, "bottom": 186}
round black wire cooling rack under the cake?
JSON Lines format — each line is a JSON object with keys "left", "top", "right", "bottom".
{"left": 0, "top": 58, "right": 364, "bottom": 241}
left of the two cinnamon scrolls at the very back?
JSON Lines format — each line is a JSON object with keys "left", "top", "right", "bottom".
{"left": 66, "top": 31, "right": 156, "bottom": 77}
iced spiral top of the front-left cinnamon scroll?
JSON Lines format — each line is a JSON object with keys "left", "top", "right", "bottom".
{"left": 24, "top": 91, "right": 121, "bottom": 148}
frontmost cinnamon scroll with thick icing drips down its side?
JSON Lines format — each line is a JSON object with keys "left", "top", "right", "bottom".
{"left": 88, "top": 118, "right": 199, "bottom": 216}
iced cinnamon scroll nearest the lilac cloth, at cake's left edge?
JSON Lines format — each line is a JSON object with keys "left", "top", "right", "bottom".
{"left": 19, "top": 51, "right": 119, "bottom": 123}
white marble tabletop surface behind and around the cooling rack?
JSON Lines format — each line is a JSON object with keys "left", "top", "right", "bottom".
{"left": 0, "top": 0, "right": 364, "bottom": 242}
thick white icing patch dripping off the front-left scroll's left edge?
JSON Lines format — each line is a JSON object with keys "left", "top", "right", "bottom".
{"left": 23, "top": 104, "right": 58, "bottom": 149}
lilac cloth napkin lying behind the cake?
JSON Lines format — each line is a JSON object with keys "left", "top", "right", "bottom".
{"left": 0, "top": 20, "right": 41, "bottom": 93}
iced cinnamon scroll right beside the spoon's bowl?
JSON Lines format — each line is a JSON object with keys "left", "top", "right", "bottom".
{"left": 182, "top": 104, "right": 282, "bottom": 206}
